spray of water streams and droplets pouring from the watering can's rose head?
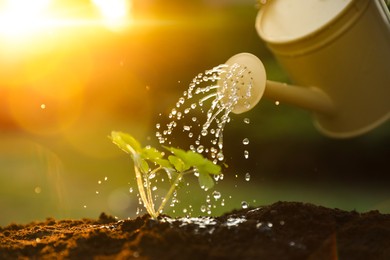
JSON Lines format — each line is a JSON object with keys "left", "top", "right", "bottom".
{"left": 156, "top": 64, "right": 253, "bottom": 164}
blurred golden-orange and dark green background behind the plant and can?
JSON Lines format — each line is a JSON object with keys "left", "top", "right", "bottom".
{"left": 0, "top": 0, "right": 390, "bottom": 225}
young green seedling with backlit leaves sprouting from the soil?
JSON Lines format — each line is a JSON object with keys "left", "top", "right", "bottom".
{"left": 111, "top": 131, "right": 221, "bottom": 218}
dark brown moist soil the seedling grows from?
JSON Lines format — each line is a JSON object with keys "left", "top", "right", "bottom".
{"left": 0, "top": 202, "right": 390, "bottom": 259}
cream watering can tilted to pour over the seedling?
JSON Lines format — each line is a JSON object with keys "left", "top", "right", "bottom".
{"left": 222, "top": 0, "right": 390, "bottom": 138}
